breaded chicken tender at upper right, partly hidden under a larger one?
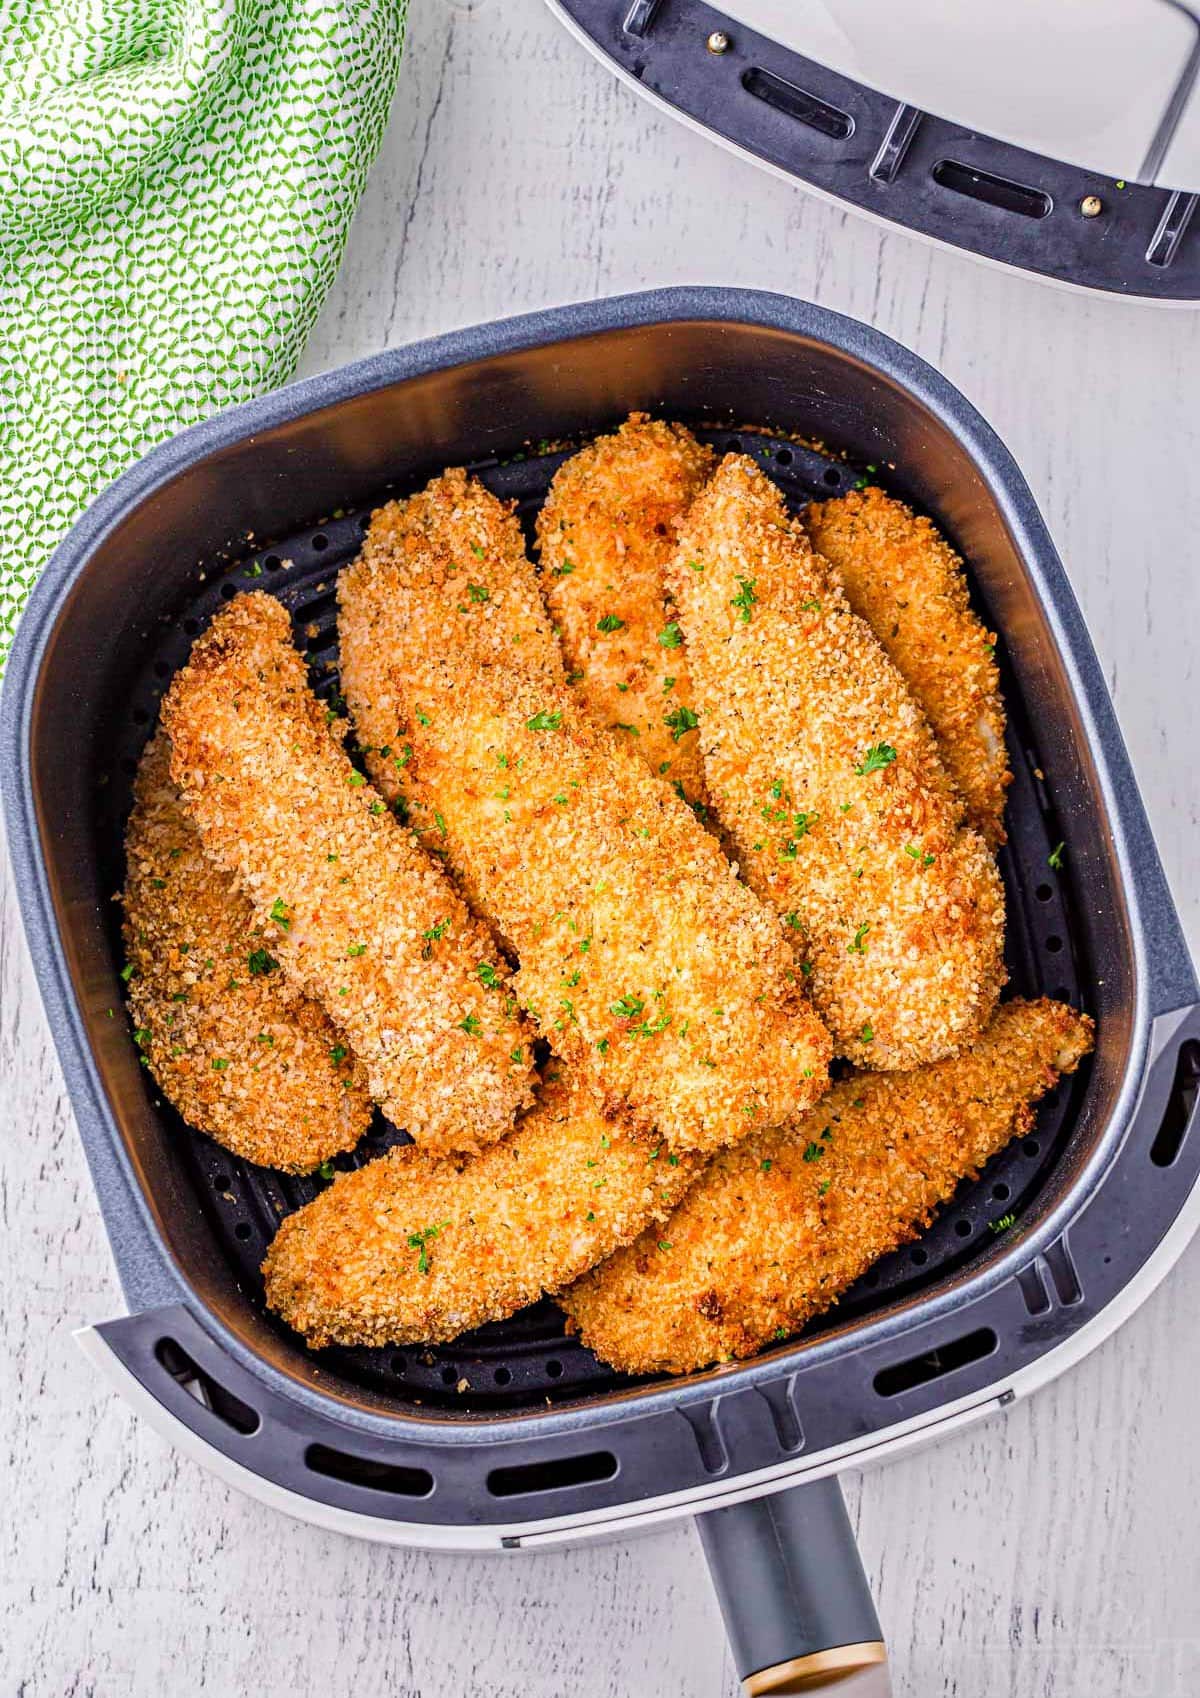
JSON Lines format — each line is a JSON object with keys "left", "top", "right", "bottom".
{"left": 801, "top": 487, "right": 1012, "bottom": 849}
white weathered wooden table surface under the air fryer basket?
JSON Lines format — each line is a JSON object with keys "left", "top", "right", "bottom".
{"left": 0, "top": 0, "right": 1200, "bottom": 1698}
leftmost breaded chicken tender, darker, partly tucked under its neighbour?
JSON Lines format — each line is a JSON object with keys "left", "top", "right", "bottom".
{"left": 124, "top": 732, "right": 372, "bottom": 1173}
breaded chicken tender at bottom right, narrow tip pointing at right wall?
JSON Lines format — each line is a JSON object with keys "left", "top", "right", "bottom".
{"left": 560, "top": 1000, "right": 1093, "bottom": 1374}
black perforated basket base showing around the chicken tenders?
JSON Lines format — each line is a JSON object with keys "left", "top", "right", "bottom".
{"left": 102, "top": 426, "right": 1085, "bottom": 1413}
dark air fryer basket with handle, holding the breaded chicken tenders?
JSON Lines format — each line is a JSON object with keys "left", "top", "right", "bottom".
{"left": 0, "top": 289, "right": 1200, "bottom": 1691}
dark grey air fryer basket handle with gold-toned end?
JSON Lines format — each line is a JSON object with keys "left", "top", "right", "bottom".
{"left": 696, "top": 1476, "right": 891, "bottom": 1698}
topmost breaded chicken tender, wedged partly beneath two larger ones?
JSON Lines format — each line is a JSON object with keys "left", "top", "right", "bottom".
{"left": 538, "top": 413, "right": 716, "bottom": 817}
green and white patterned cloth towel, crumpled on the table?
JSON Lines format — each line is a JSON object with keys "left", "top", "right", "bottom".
{"left": 0, "top": 0, "right": 406, "bottom": 671}
